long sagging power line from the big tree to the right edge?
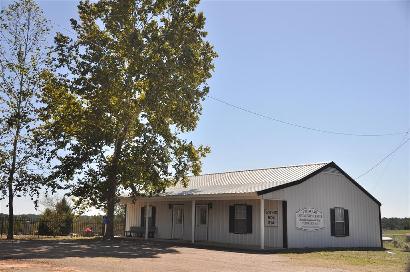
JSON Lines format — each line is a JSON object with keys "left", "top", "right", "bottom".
{"left": 207, "top": 95, "right": 409, "bottom": 137}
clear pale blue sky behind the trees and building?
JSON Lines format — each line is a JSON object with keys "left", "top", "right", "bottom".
{"left": 0, "top": 0, "right": 410, "bottom": 217}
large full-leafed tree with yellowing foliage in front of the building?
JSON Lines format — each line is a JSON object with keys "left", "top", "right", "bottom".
{"left": 42, "top": 0, "right": 217, "bottom": 238}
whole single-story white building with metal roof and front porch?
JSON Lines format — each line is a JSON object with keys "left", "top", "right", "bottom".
{"left": 122, "top": 162, "right": 382, "bottom": 249}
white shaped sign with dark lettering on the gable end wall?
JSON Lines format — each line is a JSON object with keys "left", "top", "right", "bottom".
{"left": 296, "top": 208, "right": 325, "bottom": 231}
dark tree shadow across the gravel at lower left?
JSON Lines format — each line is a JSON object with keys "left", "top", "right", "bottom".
{"left": 0, "top": 239, "right": 179, "bottom": 259}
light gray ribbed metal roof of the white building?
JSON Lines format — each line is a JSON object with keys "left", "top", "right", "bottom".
{"left": 164, "top": 163, "right": 329, "bottom": 196}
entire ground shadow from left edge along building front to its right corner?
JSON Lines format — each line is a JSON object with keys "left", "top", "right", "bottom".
{"left": 0, "top": 239, "right": 384, "bottom": 259}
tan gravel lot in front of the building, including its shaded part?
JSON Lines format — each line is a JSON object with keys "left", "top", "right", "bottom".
{"left": 0, "top": 240, "right": 404, "bottom": 272}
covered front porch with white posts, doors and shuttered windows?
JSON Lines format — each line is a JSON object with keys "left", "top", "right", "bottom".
{"left": 126, "top": 195, "right": 287, "bottom": 249}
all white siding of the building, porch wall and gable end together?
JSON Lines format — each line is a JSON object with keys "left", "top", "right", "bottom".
{"left": 126, "top": 166, "right": 381, "bottom": 248}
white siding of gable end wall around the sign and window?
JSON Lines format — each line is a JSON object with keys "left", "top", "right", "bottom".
{"left": 264, "top": 169, "right": 381, "bottom": 248}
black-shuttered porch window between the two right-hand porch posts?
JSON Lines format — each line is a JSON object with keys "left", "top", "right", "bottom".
{"left": 229, "top": 204, "right": 252, "bottom": 234}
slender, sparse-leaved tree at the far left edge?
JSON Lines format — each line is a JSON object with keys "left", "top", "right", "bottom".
{"left": 0, "top": 0, "right": 48, "bottom": 239}
